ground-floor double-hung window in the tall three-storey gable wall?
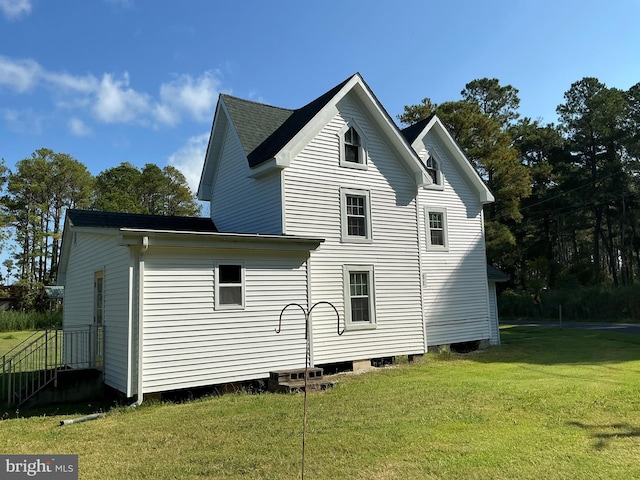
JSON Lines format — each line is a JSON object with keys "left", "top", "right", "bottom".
{"left": 344, "top": 265, "right": 376, "bottom": 330}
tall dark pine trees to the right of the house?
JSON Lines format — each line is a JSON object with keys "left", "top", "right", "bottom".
{"left": 398, "top": 77, "right": 640, "bottom": 292}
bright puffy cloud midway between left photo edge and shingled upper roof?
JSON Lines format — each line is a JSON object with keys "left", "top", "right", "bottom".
{"left": 93, "top": 72, "right": 150, "bottom": 123}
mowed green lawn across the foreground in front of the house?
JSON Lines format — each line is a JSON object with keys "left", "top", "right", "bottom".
{"left": 0, "top": 327, "right": 640, "bottom": 480}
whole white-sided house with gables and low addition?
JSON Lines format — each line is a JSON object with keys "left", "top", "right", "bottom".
{"left": 60, "top": 74, "right": 499, "bottom": 397}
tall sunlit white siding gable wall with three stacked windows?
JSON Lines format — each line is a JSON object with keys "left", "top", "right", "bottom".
{"left": 284, "top": 95, "right": 424, "bottom": 365}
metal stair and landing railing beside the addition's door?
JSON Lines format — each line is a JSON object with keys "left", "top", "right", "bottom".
{"left": 0, "top": 325, "right": 104, "bottom": 406}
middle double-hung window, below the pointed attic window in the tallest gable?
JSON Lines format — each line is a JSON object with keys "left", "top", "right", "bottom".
{"left": 340, "top": 188, "right": 372, "bottom": 243}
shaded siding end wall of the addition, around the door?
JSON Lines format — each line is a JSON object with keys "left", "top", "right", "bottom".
{"left": 63, "top": 232, "right": 130, "bottom": 393}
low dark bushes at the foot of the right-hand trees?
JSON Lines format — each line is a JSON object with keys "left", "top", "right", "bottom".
{"left": 498, "top": 285, "right": 640, "bottom": 322}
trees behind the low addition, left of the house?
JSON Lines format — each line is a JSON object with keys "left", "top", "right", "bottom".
{"left": 0, "top": 153, "right": 201, "bottom": 308}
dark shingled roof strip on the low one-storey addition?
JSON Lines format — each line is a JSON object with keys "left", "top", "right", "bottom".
{"left": 67, "top": 210, "right": 218, "bottom": 232}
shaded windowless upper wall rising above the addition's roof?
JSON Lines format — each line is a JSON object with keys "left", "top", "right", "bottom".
{"left": 211, "top": 128, "right": 282, "bottom": 235}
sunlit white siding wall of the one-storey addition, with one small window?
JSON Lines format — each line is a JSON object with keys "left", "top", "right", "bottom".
{"left": 143, "top": 247, "right": 307, "bottom": 393}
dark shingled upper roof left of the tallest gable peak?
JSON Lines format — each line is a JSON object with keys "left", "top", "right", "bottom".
{"left": 221, "top": 77, "right": 353, "bottom": 167}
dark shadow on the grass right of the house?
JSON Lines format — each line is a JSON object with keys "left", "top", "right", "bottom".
{"left": 474, "top": 325, "right": 640, "bottom": 373}
